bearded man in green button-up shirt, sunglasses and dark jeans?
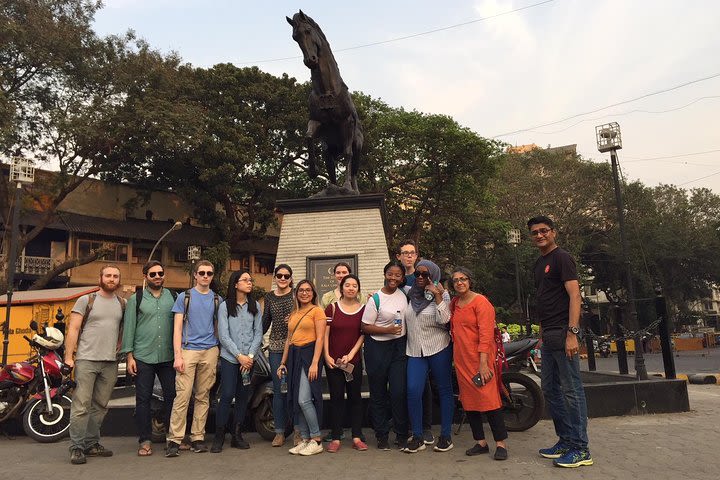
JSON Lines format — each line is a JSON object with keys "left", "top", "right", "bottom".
{"left": 122, "top": 260, "right": 175, "bottom": 457}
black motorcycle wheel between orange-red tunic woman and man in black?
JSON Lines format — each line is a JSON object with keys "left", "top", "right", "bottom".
{"left": 502, "top": 372, "right": 545, "bottom": 432}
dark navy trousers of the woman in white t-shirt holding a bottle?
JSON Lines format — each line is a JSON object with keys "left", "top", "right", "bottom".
{"left": 365, "top": 335, "right": 409, "bottom": 439}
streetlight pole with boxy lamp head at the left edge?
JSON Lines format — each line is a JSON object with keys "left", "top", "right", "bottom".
{"left": 2, "top": 158, "right": 35, "bottom": 366}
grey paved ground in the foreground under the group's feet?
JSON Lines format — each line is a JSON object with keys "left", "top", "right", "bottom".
{"left": 0, "top": 385, "right": 720, "bottom": 480}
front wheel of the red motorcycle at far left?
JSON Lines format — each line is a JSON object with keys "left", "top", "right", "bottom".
{"left": 23, "top": 395, "right": 72, "bottom": 443}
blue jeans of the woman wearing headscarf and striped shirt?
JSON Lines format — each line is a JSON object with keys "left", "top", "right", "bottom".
{"left": 407, "top": 345, "right": 455, "bottom": 438}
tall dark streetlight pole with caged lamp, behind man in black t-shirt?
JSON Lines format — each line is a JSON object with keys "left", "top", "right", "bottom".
{"left": 595, "top": 122, "right": 648, "bottom": 380}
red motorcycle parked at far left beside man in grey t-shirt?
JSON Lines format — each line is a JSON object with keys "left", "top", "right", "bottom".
{"left": 0, "top": 320, "right": 75, "bottom": 443}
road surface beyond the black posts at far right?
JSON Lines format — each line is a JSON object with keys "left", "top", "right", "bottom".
{"left": 580, "top": 348, "right": 720, "bottom": 374}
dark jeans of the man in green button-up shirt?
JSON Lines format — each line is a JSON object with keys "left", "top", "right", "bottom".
{"left": 135, "top": 359, "right": 175, "bottom": 443}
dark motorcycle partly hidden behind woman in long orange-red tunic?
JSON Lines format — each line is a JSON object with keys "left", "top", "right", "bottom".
{"left": 501, "top": 338, "right": 545, "bottom": 432}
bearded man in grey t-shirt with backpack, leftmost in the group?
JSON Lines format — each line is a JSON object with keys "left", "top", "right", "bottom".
{"left": 65, "top": 265, "right": 125, "bottom": 465}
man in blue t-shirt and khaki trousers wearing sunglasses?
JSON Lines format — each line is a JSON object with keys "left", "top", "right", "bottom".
{"left": 165, "top": 260, "right": 220, "bottom": 457}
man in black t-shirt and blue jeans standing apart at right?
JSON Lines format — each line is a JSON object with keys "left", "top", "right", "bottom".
{"left": 527, "top": 215, "right": 593, "bottom": 467}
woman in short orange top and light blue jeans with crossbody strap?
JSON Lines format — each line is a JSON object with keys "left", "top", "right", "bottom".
{"left": 277, "top": 280, "right": 327, "bottom": 455}
